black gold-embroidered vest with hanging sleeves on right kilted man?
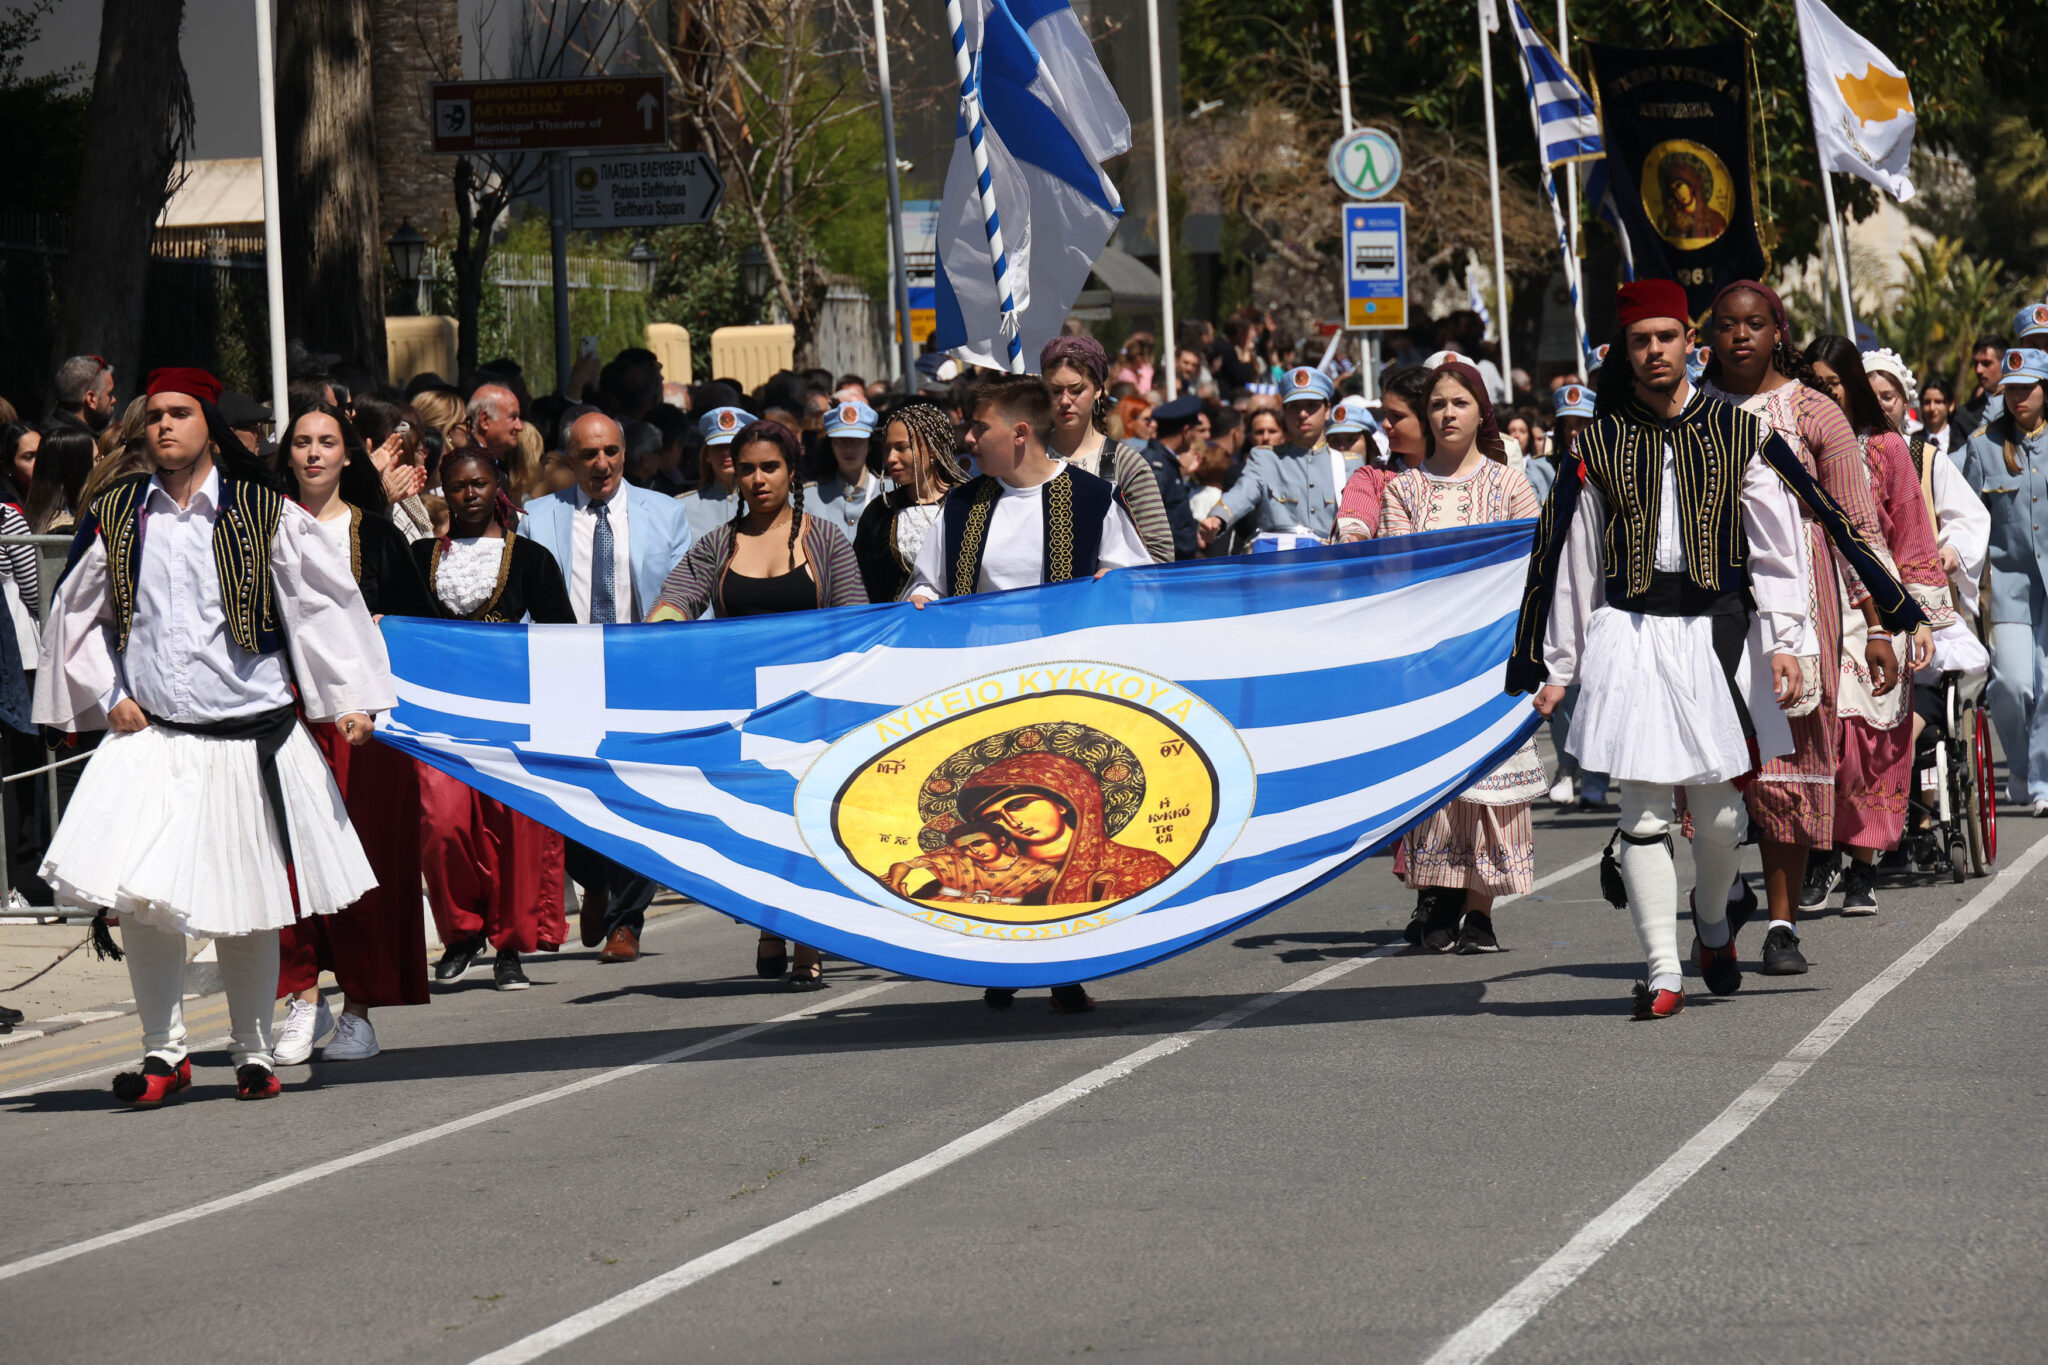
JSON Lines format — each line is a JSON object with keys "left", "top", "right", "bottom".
{"left": 1507, "top": 389, "right": 1927, "bottom": 694}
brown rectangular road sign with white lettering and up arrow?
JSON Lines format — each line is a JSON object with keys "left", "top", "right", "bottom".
{"left": 430, "top": 76, "right": 668, "bottom": 153}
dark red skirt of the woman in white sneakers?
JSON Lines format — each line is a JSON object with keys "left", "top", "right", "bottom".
{"left": 276, "top": 720, "right": 428, "bottom": 1007}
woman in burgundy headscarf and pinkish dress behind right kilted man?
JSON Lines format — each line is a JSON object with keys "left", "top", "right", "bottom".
{"left": 1695, "top": 280, "right": 1931, "bottom": 976}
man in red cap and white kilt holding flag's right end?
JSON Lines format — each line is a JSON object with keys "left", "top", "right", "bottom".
{"left": 1507, "top": 280, "right": 1921, "bottom": 1019}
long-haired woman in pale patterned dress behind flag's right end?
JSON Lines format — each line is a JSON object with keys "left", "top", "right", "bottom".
{"left": 1378, "top": 360, "right": 1546, "bottom": 954}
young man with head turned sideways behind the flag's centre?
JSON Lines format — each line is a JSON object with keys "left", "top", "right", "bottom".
{"left": 909, "top": 377, "right": 1153, "bottom": 1013}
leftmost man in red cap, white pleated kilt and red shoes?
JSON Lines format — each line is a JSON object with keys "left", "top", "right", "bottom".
{"left": 35, "top": 368, "right": 397, "bottom": 1107}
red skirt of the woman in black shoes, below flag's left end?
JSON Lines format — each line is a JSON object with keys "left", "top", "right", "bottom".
{"left": 416, "top": 763, "right": 569, "bottom": 954}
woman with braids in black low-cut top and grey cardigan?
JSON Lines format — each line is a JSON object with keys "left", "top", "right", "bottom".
{"left": 647, "top": 417, "right": 879, "bottom": 990}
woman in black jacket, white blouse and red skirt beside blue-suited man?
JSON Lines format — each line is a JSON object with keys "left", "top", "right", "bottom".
{"left": 412, "top": 446, "right": 575, "bottom": 990}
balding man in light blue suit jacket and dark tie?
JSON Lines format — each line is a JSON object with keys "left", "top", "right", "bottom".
{"left": 520, "top": 411, "right": 690, "bottom": 962}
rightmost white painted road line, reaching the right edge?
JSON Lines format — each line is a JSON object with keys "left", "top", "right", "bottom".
{"left": 1425, "top": 839, "right": 2048, "bottom": 1365}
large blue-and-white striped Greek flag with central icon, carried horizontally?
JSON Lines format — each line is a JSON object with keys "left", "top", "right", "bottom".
{"left": 379, "top": 522, "right": 1536, "bottom": 986}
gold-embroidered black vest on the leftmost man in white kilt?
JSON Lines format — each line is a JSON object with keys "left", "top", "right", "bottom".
{"left": 66, "top": 471, "right": 285, "bottom": 655}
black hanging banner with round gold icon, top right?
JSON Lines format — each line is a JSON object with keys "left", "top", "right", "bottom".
{"left": 1587, "top": 41, "right": 1765, "bottom": 315}
